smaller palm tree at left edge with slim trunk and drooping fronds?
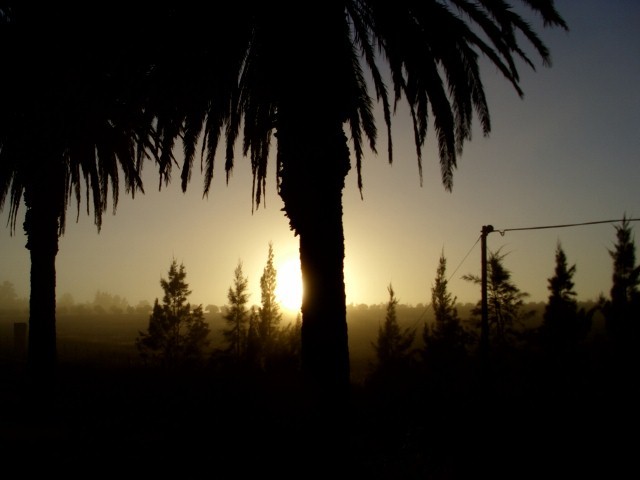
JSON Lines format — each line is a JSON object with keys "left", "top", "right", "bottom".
{"left": 0, "top": 2, "right": 158, "bottom": 378}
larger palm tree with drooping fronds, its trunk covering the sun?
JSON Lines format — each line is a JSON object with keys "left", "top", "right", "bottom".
{"left": 149, "top": 0, "right": 567, "bottom": 398}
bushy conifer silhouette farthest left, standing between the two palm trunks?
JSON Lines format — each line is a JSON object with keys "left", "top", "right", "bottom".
{"left": 136, "top": 259, "right": 209, "bottom": 369}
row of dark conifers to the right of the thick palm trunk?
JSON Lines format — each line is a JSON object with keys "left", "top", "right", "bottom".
{"left": 372, "top": 218, "right": 640, "bottom": 382}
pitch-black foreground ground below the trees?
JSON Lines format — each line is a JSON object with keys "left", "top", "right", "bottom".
{"left": 0, "top": 344, "right": 640, "bottom": 479}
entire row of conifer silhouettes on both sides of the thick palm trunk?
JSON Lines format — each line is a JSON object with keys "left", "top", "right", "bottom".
{"left": 127, "top": 219, "right": 640, "bottom": 378}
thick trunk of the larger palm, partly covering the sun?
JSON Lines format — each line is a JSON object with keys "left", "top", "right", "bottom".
{"left": 277, "top": 110, "right": 350, "bottom": 407}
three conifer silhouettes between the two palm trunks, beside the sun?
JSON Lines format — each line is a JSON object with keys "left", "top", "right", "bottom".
{"left": 135, "top": 243, "right": 302, "bottom": 371}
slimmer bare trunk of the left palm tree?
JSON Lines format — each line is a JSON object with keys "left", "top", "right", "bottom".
{"left": 24, "top": 163, "right": 64, "bottom": 380}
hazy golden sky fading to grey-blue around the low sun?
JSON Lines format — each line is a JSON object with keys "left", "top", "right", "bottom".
{"left": 0, "top": 0, "right": 640, "bottom": 312}
